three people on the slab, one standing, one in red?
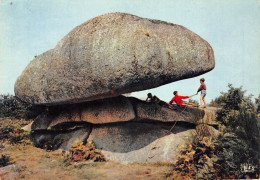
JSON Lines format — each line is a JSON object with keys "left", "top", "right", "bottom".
{"left": 146, "top": 78, "right": 207, "bottom": 108}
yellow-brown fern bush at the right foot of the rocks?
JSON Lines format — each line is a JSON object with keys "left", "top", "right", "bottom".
{"left": 173, "top": 136, "right": 217, "bottom": 179}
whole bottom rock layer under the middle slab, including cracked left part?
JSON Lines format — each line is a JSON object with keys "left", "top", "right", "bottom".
{"left": 32, "top": 119, "right": 196, "bottom": 163}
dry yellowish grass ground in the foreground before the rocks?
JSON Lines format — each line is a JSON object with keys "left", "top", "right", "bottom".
{"left": 0, "top": 143, "right": 175, "bottom": 180}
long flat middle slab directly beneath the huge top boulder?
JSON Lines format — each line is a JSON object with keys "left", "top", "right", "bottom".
{"left": 32, "top": 96, "right": 205, "bottom": 130}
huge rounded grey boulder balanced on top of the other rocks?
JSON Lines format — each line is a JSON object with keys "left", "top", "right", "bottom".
{"left": 15, "top": 13, "right": 215, "bottom": 105}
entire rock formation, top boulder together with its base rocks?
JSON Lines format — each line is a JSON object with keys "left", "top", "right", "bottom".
{"left": 15, "top": 13, "right": 217, "bottom": 162}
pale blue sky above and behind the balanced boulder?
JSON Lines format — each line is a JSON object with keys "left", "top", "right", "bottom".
{"left": 0, "top": 0, "right": 260, "bottom": 102}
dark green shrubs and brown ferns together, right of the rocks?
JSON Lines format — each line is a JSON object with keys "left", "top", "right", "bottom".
{"left": 173, "top": 84, "right": 260, "bottom": 179}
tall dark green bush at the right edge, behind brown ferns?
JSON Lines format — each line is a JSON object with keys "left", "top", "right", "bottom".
{"left": 215, "top": 84, "right": 259, "bottom": 178}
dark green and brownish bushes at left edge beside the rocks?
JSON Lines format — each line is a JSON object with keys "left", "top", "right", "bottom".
{"left": 0, "top": 95, "right": 45, "bottom": 144}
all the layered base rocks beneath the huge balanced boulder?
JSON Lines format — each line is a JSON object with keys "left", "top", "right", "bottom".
{"left": 31, "top": 96, "right": 218, "bottom": 163}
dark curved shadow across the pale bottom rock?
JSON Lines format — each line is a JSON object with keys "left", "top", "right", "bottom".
{"left": 88, "top": 122, "right": 195, "bottom": 153}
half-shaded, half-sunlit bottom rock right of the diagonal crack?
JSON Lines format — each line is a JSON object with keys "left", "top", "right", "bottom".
{"left": 88, "top": 122, "right": 195, "bottom": 163}
